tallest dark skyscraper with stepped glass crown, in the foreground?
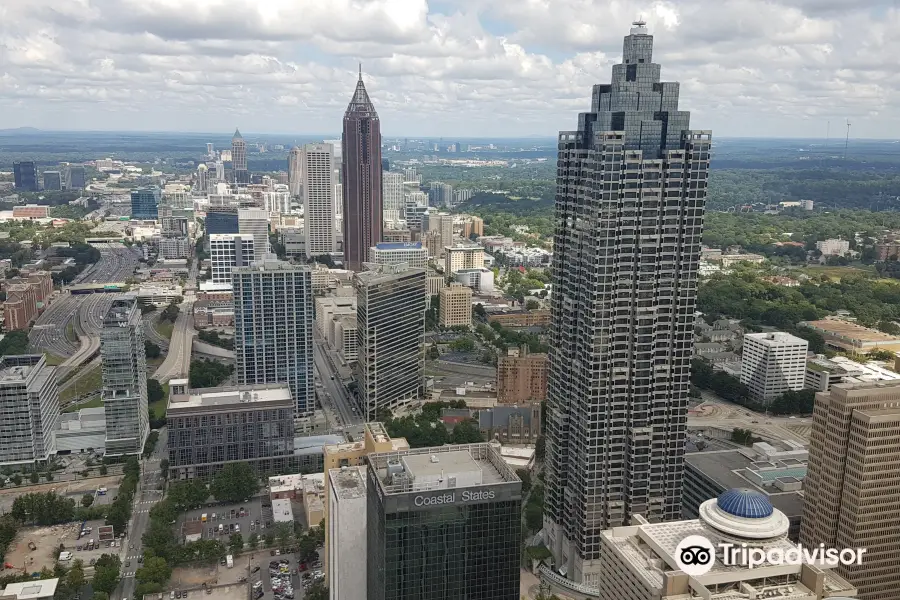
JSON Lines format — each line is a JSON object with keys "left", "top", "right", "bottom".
{"left": 544, "top": 22, "right": 711, "bottom": 585}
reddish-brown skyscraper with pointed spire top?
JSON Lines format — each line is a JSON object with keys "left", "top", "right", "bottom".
{"left": 341, "top": 68, "right": 383, "bottom": 271}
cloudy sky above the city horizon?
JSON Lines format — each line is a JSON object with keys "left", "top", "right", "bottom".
{"left": 0, "top": 0, "right": 900, "bottom": 138}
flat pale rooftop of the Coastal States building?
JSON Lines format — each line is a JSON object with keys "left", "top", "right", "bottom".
{"left": 368, "top": 443, "right": 519, "bottom": 495}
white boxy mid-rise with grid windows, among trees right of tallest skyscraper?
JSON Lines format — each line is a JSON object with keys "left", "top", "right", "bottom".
{"left": 741, "top": 331, "right": 809, "bottom": 404}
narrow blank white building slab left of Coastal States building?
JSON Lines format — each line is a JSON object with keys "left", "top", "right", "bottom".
{"left": 326, "top": 467, "right": 367, "bottom": 600}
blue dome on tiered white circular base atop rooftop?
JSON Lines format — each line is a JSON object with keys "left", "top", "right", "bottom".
{"left": 700, "top": 489, "right": 790, "bottom": 540}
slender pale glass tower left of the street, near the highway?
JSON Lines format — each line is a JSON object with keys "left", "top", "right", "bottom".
{"left": 100, "top": 296, "right": 150, "bottom": 456}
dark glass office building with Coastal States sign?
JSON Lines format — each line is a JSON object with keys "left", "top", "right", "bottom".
{"left": 366, "top": 444, "right": 522, "bottom": 600}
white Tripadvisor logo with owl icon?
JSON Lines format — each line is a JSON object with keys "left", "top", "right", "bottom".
{"left": 675, "top": 535, "right": 866, "bottom": 577}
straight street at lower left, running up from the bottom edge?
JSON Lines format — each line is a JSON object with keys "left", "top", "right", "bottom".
{"left": 112, "top": 428, "right": 166, "bottom": 600}
